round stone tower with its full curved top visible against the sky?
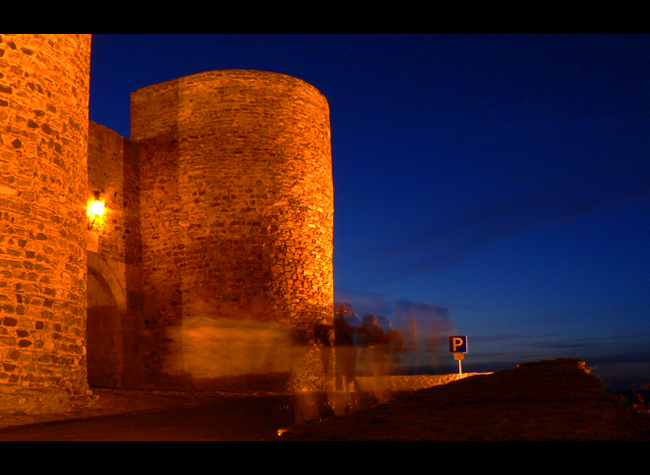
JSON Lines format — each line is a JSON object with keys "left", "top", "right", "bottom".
{"left": 131, "top": 70, "right": 334, "bottom": 391}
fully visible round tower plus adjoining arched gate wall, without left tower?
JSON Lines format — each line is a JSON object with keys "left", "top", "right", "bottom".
{"left": 88, "top": 71, "right": 333, "bottom": 390}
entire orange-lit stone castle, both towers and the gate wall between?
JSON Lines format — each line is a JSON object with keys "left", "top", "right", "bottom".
{"left": 0, "top": 34, "right": 334, "bottom": 413}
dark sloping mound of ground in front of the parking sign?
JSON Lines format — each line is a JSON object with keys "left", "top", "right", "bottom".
{"left": 279, "top": 359, "right": 650, "bottom": 441}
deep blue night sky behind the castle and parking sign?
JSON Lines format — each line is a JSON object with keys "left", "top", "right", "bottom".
{"left": 90, "top": 34, "right": 650, "bottom": 387}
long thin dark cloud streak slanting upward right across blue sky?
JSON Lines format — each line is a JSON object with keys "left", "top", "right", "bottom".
{"left": 366, "top": 176, "right": 650, "bottom": 285}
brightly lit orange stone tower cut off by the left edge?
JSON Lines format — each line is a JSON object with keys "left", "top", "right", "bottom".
{"left": 0, "top": 34, "right": 91, "bottom": 413}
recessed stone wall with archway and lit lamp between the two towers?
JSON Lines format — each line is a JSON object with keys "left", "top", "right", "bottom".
{"left": 87, "top": 122, "right": 144, "bottom": 387}
